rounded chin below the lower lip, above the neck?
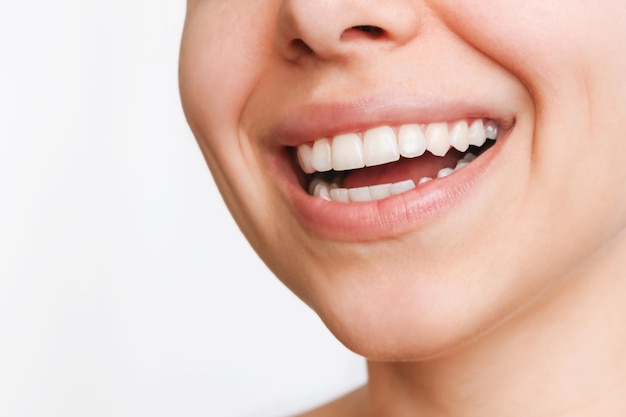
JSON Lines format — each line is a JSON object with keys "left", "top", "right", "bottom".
{"left": 296, "top": 260, "right": 520, "bottom": 361}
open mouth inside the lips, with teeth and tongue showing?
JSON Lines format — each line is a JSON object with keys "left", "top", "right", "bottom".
{"left": 296, "top": 118, "right": 504, "bottom": 203}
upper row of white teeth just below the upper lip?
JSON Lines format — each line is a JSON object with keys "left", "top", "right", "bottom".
{"left": 298, "top": 119, "right": 498, "bottom": 174}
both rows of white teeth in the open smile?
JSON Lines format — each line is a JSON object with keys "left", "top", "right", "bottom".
{"left": 297, "top": 119, "right": 498, "bottom": 203}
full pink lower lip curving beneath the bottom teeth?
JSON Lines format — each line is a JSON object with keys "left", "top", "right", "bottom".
{"left": 283, "top": 138, "right": 505, "bottom": 242}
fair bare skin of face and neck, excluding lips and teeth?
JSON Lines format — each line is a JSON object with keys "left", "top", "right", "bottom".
{"left": 180, "top": 0, "right": 626, "bottom": 417}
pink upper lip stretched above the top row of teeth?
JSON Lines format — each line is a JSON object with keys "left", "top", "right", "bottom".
{"left": 269, "top": 95, "right": 514, "bottom": 147}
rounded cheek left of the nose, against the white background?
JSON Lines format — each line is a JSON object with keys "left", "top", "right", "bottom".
{"left": 180, "top": 0, "right": 275, "bottom": 134}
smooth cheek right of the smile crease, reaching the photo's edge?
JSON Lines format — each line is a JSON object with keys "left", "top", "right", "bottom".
{"left": 437, "top": 0, "right": 626, "bottom": 189}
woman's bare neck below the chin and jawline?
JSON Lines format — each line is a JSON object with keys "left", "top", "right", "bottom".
{"left": 367, "top": 229, "right": 626, "bottom": 417}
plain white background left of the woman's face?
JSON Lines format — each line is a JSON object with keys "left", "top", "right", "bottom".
{"left": 0, "top": 0, "right": 365, "bottom": 417}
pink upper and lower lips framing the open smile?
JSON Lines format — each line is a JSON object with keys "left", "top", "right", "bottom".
{"left": 268, "top": 97, "right": 515, "bottom": 242}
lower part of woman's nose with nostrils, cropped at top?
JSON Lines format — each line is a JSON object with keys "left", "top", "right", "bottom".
{"left": 276, "top": 0, "right": 421, "bottom": 61}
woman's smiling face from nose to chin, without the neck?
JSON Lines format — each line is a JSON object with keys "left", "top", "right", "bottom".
{"left": 180, "top": 0, "right": 626, "bottom": 359}
